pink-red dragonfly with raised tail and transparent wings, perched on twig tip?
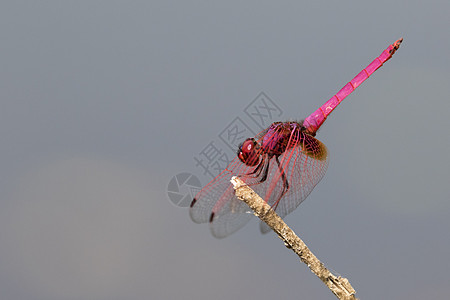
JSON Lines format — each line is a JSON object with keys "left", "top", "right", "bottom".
{"left": 190, "top": 39, "right": 403, "bottom": 238}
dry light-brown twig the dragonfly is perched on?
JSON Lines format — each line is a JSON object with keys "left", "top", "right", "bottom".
{"left": 231, "top": 176, "right": 357, "bottom": 300}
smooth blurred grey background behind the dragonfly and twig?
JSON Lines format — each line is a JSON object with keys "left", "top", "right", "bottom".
{"left": 0, "top": 0, "right": 450, "bottom": 300}
